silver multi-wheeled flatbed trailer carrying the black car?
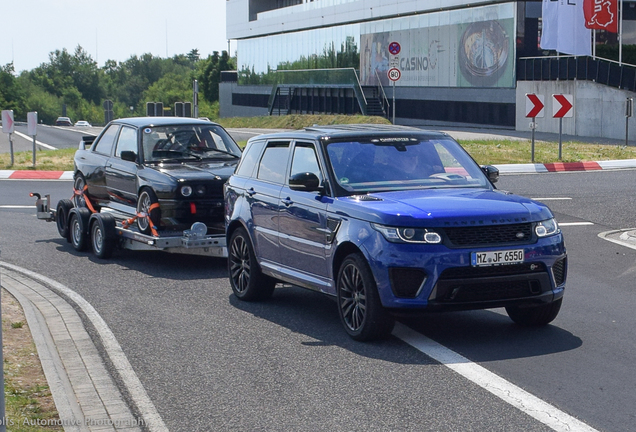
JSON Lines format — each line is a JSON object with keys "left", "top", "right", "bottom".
{"left": 30, "top": 192, "right": 228, "bottom": 259}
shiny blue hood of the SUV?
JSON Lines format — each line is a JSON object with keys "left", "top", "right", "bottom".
{"left": 336, "top": 188, "right": 552, "bottom": 228}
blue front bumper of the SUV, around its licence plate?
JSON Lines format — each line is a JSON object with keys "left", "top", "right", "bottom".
{"left": 365, "top": 234, "right": 567, "bottom": 311}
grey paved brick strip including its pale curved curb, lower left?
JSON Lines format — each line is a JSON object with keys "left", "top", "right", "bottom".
{"left": 0, "top": 261, "right": 168, "bottom": 432}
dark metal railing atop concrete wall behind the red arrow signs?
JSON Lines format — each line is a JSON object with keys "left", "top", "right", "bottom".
{"left": 517, "top": 56, "right": 636, "bottom": 91}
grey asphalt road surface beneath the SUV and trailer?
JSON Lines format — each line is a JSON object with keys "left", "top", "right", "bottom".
{"left": 0, "top": 170, "right": 636, "bottom": 431}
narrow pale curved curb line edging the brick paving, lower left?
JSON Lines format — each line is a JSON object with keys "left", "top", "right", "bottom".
{"left": 0, "top": 261, "right": 168, "bottom": 432}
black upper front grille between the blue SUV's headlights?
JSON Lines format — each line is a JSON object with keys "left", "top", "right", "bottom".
{"left": 443, "top": 223, "right": 535, "bottom": 248}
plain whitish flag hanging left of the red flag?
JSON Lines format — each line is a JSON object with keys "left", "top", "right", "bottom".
{"left": 541, "top": 0, "right": 592, "bottom": 55}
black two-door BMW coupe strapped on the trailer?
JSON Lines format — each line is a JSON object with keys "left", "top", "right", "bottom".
{"left": 74, "top": 117, "right": 241, "bottom": 234}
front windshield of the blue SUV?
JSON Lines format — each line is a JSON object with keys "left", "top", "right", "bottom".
{"left": 327, "top": 138, "right": 490, "bottom": 193}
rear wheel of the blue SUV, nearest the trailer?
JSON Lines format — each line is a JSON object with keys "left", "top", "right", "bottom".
{"left": 227, "top": 228, "right": 276, "bottom": 301}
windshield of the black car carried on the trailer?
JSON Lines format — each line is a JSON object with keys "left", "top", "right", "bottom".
{"left": 142, "top": 124, "right": 241, "bottom": 162}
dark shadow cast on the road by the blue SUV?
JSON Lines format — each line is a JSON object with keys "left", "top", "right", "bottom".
{"left": 229, "top": 286, "right": 583, "bottom": 363}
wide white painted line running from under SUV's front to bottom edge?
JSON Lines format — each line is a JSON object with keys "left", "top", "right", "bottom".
{"left": 393, "top": 323, "right": 596, "bottom": 432}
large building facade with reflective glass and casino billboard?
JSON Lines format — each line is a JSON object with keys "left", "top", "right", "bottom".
{"left": 221, "top": 0, "right": 542, "bottom": 127}
